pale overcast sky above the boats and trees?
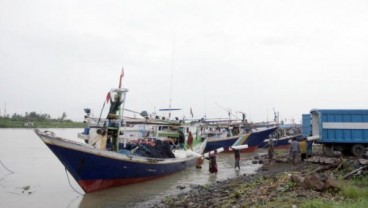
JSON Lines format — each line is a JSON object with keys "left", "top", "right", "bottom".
{"left": 0, "top": 0, "right": 368, "bottom": 123}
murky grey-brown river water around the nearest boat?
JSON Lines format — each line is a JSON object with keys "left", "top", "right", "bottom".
{"left": 0, "top": 129, "right": 260, "bottom": 208}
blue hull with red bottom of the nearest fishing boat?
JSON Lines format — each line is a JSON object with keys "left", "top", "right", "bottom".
{"left": 36, "top": 132, "right": 203, "bottom": 193}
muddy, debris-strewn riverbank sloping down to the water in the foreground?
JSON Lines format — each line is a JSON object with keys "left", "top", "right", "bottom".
{"left": 151, "top": 150, "right": 368, "bottom": 208}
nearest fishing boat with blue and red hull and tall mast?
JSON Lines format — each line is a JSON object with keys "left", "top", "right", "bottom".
{"left": 35, "top": 72, "right": 206, "bottom": 193}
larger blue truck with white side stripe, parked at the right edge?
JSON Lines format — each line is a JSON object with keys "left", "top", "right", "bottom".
{"left": 302, "top": 109, "right": 368, "bottom": 157}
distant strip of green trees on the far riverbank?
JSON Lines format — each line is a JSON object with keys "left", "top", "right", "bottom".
{"left": 0, "top": 112, "right": 85, "bottom": 128}
